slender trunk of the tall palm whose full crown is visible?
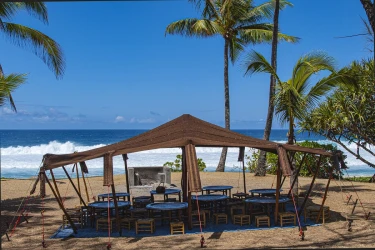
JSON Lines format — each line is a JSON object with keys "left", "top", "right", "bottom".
{"left": 216, "top": 39, "right": 230, "bottom": 172}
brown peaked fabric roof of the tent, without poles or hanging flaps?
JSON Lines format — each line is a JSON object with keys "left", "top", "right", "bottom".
{"left": 43, "top": 114, "right": 332, "bottom": 169}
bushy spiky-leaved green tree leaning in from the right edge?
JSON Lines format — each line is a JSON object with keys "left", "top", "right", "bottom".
{"left": 299, "top": 58, "right": 375, "bottom": 168}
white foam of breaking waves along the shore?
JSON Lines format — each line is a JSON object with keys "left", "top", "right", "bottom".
{"left": 0, "top": 140, "right": 375, "bottom": 176}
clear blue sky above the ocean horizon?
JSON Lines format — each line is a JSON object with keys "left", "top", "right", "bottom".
{"left": 0, "top": 0, "right": 371, "bottom": 129}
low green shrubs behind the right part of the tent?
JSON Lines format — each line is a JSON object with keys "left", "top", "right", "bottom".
{"left": 246, "top": 141, "right": 346, "bottom": 178}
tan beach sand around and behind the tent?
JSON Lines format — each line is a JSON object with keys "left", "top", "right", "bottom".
{"left": 1, "top": 172, "right": 375, "bottom": 249}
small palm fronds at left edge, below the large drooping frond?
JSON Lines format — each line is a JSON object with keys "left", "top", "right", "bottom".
{"left": 0, "top": 65, "right": 26, "bottom": 112}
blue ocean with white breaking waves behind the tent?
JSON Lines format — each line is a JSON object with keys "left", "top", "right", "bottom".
{"left": 0, "top": 129, "right": 375, "bottom": 178}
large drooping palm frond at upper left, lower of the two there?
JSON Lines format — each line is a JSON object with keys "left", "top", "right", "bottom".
{"left": 3, "top": 22, "right": 65, "bottom": 78}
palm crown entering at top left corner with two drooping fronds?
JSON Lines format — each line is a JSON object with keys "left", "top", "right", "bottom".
{"left": 0, "top": 1, "right": 65, "bottom": 78}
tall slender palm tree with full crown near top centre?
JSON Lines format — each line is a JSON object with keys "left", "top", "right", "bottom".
{"left": 166, "top": 0, "right": 296, "bottom": 172}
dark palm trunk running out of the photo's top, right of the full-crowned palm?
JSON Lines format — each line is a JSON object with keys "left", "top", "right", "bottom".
{"left": 255, "top": 0, "right": 280, "bottom": 176}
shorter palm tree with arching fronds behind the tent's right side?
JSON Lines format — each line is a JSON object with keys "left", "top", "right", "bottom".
{"left": 245, "top": 51, "right": 347, "bottom": 191}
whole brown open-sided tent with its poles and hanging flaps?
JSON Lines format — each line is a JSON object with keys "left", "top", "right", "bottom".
{"left": 34, "top": 114, "right": 340, "bottom": 231}
